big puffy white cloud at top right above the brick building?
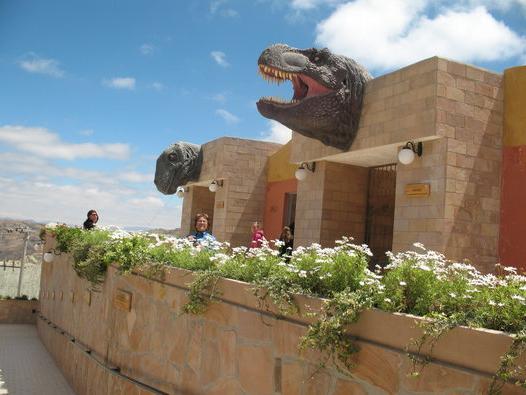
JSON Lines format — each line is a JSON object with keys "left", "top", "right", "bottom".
{"left": 316, "top": 0, "right": 526, "bottom": 70}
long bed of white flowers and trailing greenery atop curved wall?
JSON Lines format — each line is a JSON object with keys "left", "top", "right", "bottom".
{"left": 44, "top": 227, "right": 526, "bottom": 393}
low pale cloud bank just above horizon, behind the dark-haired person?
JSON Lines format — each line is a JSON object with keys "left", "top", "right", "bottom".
{"left": 0, "top": 177, "right": 181, "bottom": 229}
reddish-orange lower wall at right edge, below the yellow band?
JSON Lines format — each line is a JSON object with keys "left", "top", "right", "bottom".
{"left": 499, "top": 145, "right": 526, "bottom": 271}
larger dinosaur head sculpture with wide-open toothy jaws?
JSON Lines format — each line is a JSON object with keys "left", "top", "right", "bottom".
{"left": 257, "top": 44, "right": 372, "bottom": 150}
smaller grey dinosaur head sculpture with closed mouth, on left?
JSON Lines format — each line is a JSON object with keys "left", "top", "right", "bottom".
{"left": 154, "top": 141, "right": 203, "bottom": 195}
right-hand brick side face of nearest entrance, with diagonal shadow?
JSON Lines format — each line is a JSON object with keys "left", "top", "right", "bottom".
{"left": 437, "top": 59, "right": 503, "bottom": 271}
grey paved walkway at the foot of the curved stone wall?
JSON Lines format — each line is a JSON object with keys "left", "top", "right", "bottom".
{"left": 0, "top": 324, "right": 75, "bottom": 395}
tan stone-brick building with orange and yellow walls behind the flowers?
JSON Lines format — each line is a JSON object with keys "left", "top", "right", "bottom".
{"left": 181, "top": 57, "right": 526, "bottom": 271}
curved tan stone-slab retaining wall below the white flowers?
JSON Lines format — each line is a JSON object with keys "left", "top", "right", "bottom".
{"left": 38, "top": 240, "right": 521, "bottom": 395}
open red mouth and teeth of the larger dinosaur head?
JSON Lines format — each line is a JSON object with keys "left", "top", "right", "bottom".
{"left": 259, "top": 64, "right": 334, "bottom": 104}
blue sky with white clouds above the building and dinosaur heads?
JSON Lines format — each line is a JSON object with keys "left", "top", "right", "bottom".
{"left": 0, "top": 0, "right": 526, "bottom": 229}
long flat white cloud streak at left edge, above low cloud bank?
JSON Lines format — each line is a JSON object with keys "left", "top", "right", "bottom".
{"left": 0, "top": 125, "right": 130, "bottom": 160}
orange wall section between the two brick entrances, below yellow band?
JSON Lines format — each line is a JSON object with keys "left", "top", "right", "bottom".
{"left": 263, "top": 178, "right": 298, "bottom": 240}
